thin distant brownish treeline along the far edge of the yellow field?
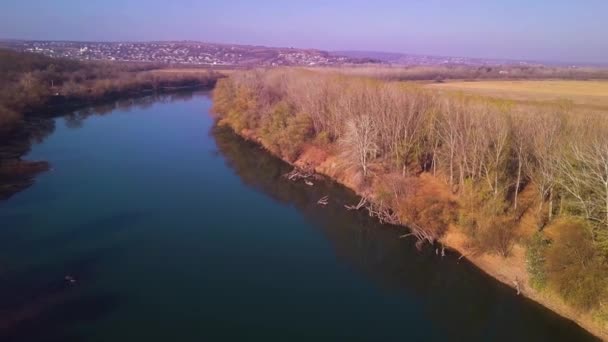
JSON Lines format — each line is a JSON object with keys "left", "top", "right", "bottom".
{"left": 316, "top": 65, "right": 608, "bottom": 82}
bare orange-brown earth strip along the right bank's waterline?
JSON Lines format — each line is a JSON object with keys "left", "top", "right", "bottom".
{"left": 221, "top": 125, "right": 608, "bottom": 341}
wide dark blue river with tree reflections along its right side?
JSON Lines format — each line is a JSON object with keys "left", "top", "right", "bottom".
{"left": 0, "top": 92, "right": 594, "bottom": 341}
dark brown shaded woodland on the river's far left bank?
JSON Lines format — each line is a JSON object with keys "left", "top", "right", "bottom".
{"left": 0, "top": 49, "right": 220, "bottom": 133}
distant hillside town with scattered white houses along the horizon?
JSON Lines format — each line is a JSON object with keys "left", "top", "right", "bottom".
{"left": 0, "top": 40, "right": 588, "bottom": 67}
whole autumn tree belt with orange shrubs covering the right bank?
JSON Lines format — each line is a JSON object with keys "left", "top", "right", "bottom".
{"left": 214, "top": 69, "right": 608, "bottom": 314}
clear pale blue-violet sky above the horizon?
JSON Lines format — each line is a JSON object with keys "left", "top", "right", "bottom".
{"left": 0, "top": 0, "right": 608, "bottom": 63}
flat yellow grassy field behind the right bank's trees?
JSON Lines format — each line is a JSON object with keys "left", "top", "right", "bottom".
{"left": 427, "top": 80, "right": 608, "bottom": 110}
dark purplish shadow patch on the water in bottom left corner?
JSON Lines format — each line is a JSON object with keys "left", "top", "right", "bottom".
{"left": 0, "top": 248, "right": 121, "bottom": 341}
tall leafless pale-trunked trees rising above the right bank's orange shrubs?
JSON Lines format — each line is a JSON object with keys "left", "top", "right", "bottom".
{"left": 216, "top": 69, "right": 608, "bottom": 253}
